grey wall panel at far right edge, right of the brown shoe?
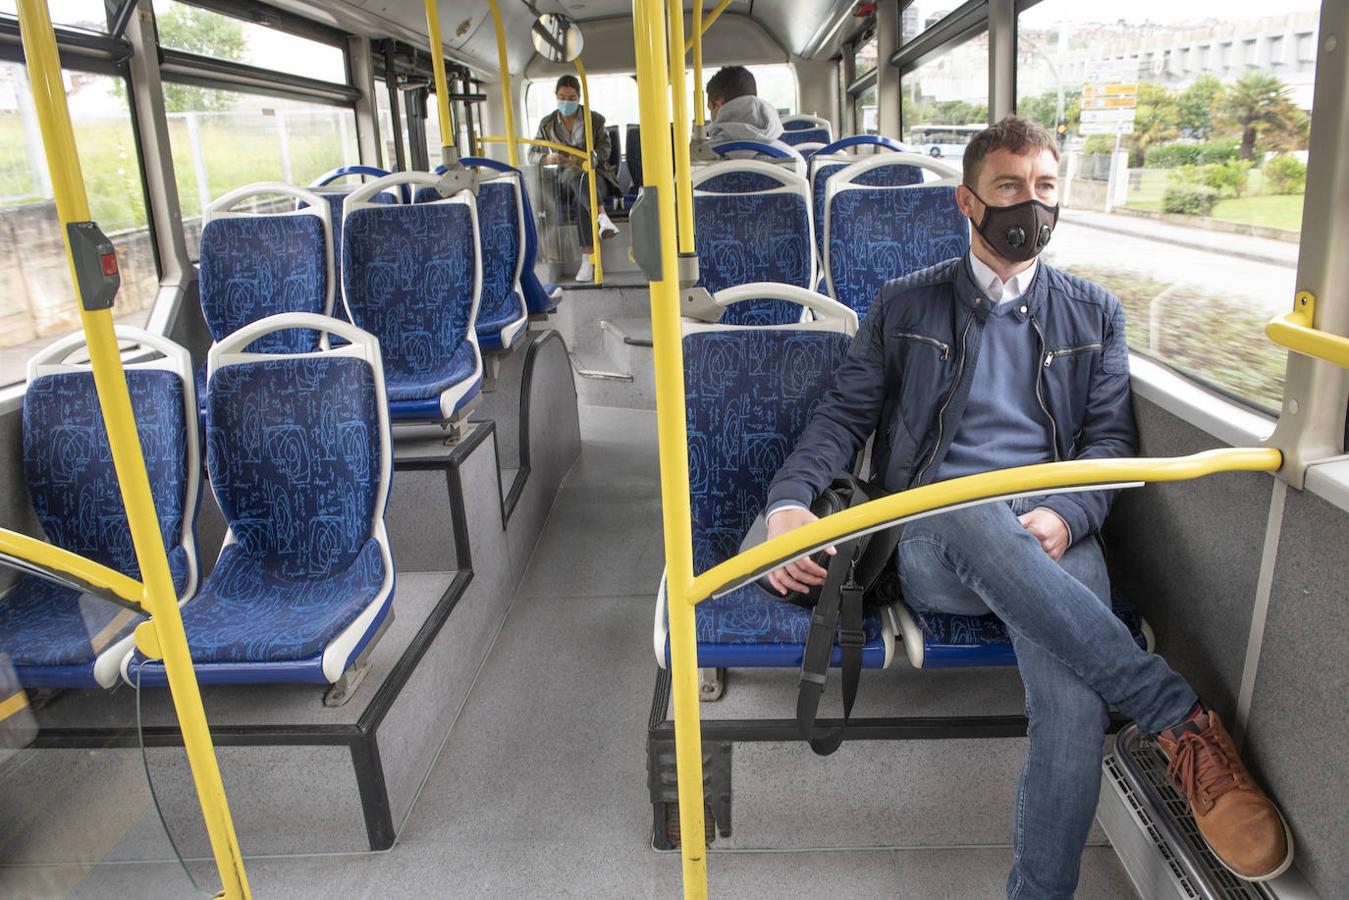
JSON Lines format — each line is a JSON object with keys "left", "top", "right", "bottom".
{"left": 1245, "top": 491, "right": 1349, "bottom": 897}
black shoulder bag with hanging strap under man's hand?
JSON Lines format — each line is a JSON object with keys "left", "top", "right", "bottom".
{"left": 746, "top": 475, "right": 900, "bottom": 756}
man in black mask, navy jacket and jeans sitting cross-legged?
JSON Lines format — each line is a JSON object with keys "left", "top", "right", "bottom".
{"left": 768, "top": 116, "right": 1292, "bottom": 897}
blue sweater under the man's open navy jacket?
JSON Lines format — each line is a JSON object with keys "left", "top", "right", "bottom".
{"left": 935, "top": 300, "right": 1054, "bottom": 482}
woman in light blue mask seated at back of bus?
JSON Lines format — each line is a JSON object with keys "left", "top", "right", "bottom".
{"left": 529, "top": 76, "right": 622, "bottom": 282}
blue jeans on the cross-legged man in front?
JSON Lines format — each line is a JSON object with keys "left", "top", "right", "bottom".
{"left": 898, "top": 498, "right": 1197, "bottom": 900}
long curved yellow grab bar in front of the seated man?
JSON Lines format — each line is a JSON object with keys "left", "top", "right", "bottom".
{"left": 688, "top": 447, "right": 1283, "bottom": 603}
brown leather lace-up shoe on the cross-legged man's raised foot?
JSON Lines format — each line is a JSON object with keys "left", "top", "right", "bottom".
{"left": 1157, "top": 710, "right": 1292, "bottom": 881}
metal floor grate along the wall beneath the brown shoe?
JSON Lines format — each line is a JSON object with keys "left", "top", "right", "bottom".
{"left": 1105, "top": 725, "right": 1272, "bottom": 900}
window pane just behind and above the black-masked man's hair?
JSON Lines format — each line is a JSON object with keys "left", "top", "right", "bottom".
{"left": 900, "top": 31, "right": 989, "bottom": 143}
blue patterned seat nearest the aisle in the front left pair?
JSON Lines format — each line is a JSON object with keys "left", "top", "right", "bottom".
{"left": 125, "top": 354, "right": 393, "bottom": 685}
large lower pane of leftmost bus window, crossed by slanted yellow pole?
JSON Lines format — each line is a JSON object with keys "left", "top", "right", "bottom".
{"left": 0, "top": 62, "right": 159, "bottom": 385}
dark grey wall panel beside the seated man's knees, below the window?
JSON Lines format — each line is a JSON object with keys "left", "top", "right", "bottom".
{"left": 1106, "top": 398, "right": 1273, "bottom": 721}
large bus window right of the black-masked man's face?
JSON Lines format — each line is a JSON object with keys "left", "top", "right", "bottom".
{"left": 1017, "top": 0, "right": 1321, "bottom": 412}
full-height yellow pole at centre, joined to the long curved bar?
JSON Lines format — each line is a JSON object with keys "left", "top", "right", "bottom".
{"left": 633, "top": 0, "right": 707, "bottom": 900}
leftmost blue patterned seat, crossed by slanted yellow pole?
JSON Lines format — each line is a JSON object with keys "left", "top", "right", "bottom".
{"left": 0, "top": 367, "right": 198, "bottom": 688}
